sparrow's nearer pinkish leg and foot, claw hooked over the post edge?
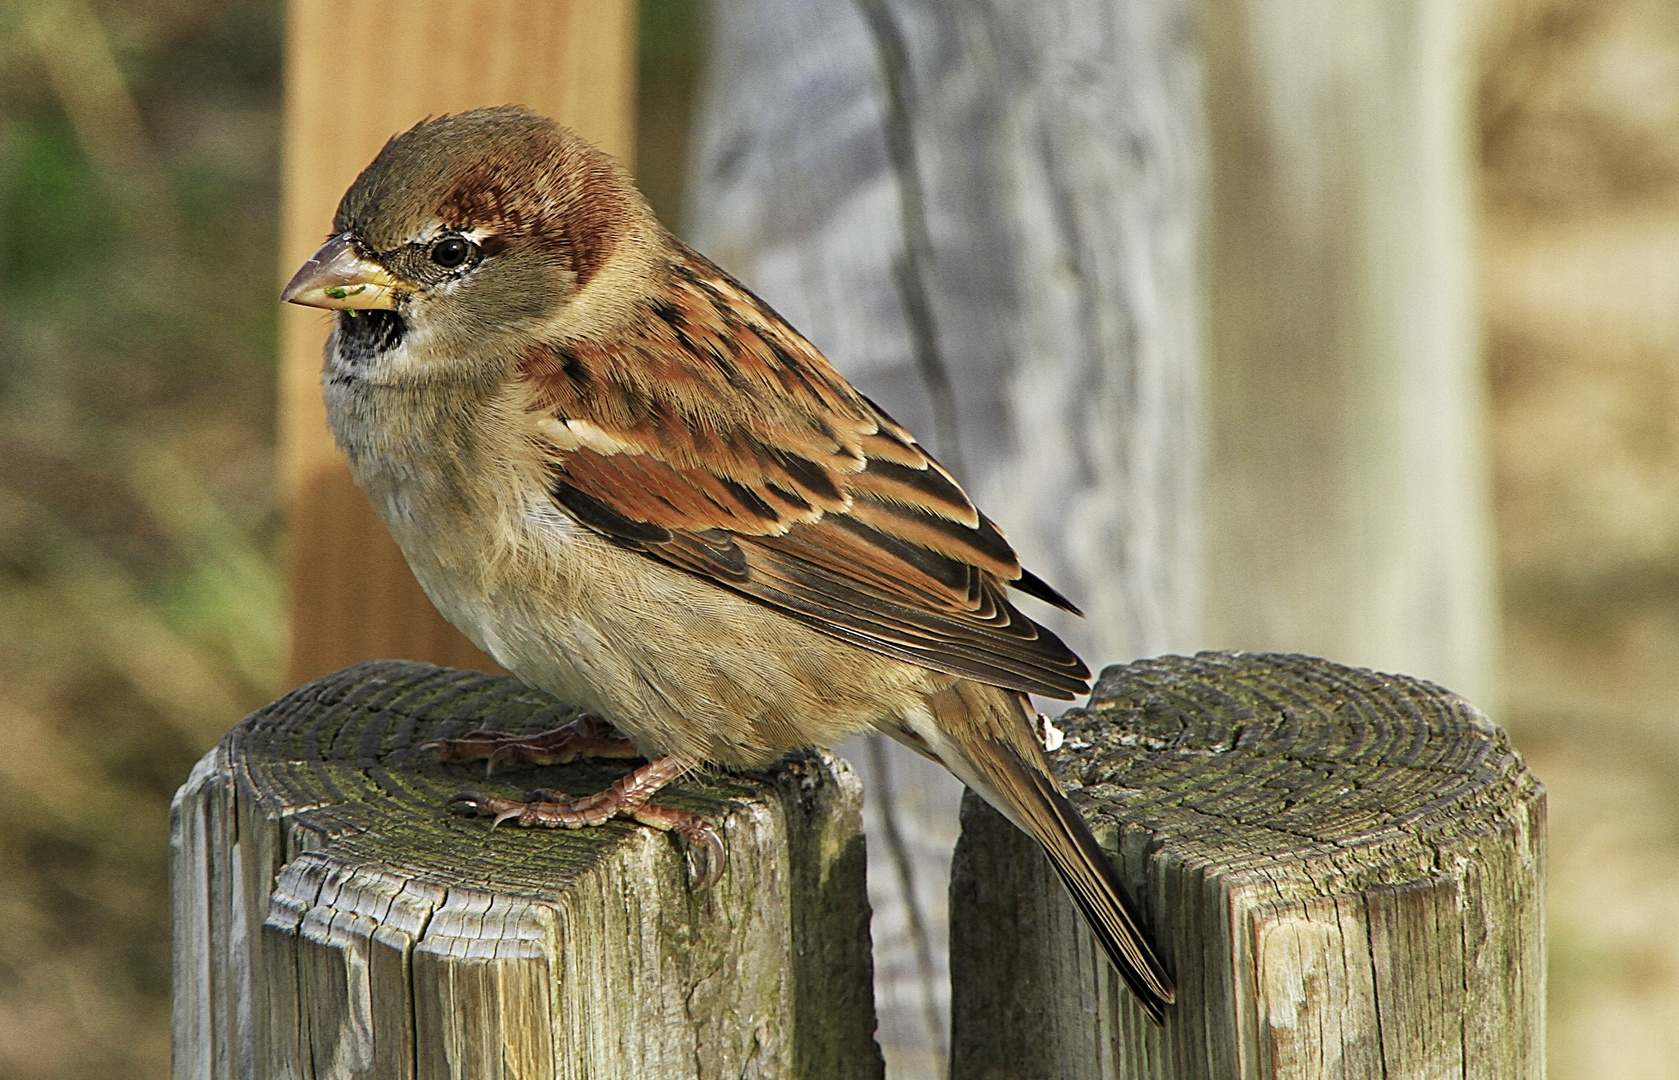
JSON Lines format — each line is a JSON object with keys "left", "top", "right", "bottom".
{"left": 448, "top": 754, "right": 724, "bottom": 889}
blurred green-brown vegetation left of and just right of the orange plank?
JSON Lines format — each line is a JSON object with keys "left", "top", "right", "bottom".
{"left": 0, "top": 0, "right": 698, "bottom": 1080}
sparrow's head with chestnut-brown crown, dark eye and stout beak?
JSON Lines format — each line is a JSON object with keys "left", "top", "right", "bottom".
{"left": 280, "top": 106, "right": 658, "bottom": 382}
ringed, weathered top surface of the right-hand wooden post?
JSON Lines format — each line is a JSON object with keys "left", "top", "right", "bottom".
{"left": 1054, "top": 653, "right": 1538, "bottom": 885}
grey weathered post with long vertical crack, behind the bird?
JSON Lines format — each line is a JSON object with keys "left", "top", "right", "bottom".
{"left": 685, "top": 0, "right": 1206, "bottom": 1077}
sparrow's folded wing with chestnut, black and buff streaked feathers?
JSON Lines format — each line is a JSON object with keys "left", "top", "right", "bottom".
{"left": 520, "top": 252, "right": 1090, "bottom": 697}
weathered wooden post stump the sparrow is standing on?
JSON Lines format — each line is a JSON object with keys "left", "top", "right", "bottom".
{"left": 171, "top": 662, "right": 881, "bottom": 1080}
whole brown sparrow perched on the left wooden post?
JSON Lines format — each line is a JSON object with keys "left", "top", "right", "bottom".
{"left": 282, "top": 106, "right": 1172, "bottom": 1021}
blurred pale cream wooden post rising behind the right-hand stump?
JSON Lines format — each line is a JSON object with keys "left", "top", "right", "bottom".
{"left": 1202, "top": 0, "right": 1499, "bottom": 712}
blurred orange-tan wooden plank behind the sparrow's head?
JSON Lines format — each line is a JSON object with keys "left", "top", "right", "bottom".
{"left": 275, "top": 0, "right": 635, "bottom": 685}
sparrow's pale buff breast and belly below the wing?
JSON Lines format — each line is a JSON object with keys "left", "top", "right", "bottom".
{"left": 353, "top": 384, "right": 954, "bottom": 766}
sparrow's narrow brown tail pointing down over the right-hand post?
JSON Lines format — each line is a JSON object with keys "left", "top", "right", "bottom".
{"left": 915, "top": 682, "right": 1175, "bottom": 1023}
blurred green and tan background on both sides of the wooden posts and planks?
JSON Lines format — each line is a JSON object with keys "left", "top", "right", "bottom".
{"left": 0, "top": 0, "right": 1679, "bottom": 1080}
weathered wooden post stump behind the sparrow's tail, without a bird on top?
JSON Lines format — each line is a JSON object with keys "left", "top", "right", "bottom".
{"left": 950, "top": 653, "right": 1545, "bottom": 1080}
